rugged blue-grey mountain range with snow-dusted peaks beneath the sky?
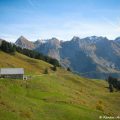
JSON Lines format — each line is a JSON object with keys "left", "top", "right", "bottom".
{"left": 6, "top": 36, "right": 120, "bottom": 79}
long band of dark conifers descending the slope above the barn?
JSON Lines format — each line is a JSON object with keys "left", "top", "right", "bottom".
{"left": 0, "top": 41, "right": 60, "bottom": 67}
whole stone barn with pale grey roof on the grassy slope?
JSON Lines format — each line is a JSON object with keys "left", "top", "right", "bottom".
{"left": 0, "top": 68, "right": 24, "bottom": 79}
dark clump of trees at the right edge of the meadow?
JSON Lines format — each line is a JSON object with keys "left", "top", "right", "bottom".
{"left": 107, "top": 76, "right": 120, "bottom": 92}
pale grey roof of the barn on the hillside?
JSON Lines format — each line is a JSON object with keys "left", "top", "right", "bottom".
{"left": 0, "top": 68, "right": 24, "bottom": 75}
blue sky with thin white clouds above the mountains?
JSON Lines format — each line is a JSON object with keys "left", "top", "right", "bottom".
{"left": 0, "top": 0, "right": 120, "bottom": 42}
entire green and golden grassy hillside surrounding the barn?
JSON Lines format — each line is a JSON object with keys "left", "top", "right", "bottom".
{"left": 0, "top": 52, "right": 120, "bottom": 120}
